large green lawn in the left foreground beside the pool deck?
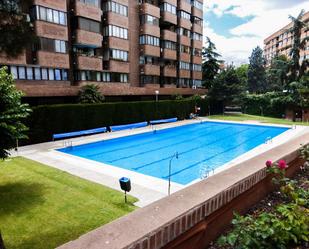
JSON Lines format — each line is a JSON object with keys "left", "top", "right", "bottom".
{"left": 0, "top": 157, "right": 136, "bottom": 249}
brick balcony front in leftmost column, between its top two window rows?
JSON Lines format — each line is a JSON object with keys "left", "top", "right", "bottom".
{"left": 34, "top": 21, "right": 68, "bottom": 41}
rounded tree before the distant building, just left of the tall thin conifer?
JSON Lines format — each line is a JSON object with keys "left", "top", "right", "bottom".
{"left": 266, "top": 55, "right": 290, "bottom": 91}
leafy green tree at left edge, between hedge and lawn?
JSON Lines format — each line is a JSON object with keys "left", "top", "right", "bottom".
{"left": 0, "top": 67, "right": 31, "bottom": 159}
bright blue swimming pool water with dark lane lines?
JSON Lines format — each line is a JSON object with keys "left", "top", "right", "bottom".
{"left": 59, "top": 122, "right": 288, "bottom": 184}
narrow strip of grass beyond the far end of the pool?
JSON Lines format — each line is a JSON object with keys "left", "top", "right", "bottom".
{"left": 208, "top": 114, "right": 309, "bottom": 125}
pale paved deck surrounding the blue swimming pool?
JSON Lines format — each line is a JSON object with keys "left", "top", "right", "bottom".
{"left": 11, "top": 118, "right": 309, "bottom": 207}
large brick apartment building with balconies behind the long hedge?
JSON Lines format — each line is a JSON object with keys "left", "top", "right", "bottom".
{"left": 0, "top": 0, "right": 205, "bottom": 103}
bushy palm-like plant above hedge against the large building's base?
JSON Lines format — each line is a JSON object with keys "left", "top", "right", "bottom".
{"left": 79, "top": 84, "right": 105, "bottom": 104}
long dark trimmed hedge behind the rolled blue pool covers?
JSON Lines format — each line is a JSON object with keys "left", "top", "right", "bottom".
{"left": 25, "top": 99, "right": 209, "bottom": 143}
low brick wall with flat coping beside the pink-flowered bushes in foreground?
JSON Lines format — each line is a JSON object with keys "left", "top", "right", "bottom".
{"left": 59, "top": 133, "right": 309, "bottom": 249}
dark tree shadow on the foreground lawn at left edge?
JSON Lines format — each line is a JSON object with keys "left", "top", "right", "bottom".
{"left": 0, "top": 182, "right": 44, "bottom": 217}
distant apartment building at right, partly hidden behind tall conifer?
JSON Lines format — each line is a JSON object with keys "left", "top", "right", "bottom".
{"left": 264, "top": 12, "right": 309, "bottom": 66}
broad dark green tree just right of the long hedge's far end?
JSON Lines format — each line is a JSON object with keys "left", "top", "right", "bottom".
{"left": 209, "top": 66, "right": 245, "bottom": 110}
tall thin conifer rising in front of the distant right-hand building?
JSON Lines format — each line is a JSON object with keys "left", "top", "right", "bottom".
{"left": 288, "top": 10, "right": 309, "bottom": 81}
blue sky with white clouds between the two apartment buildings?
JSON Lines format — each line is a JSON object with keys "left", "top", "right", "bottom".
{"left": 204, "top": 0, "right": 309, "bottom": 65}
